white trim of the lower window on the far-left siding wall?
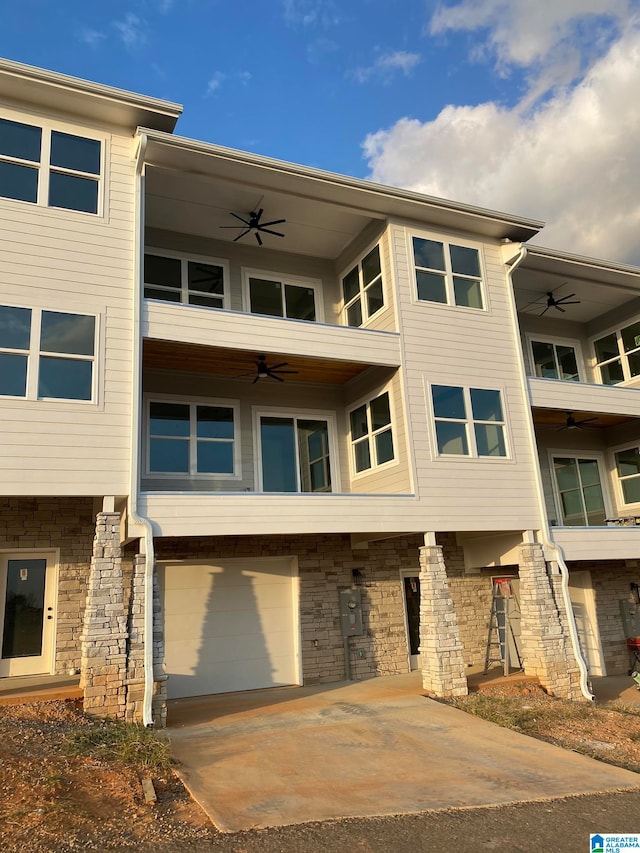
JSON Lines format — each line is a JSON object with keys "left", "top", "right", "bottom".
{"left": 0, "top": 301, "right": 99, "bottom": 407}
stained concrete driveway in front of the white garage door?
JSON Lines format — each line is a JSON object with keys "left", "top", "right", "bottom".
{"left": 169, "top": 673, "right": 640, "bottom": 832}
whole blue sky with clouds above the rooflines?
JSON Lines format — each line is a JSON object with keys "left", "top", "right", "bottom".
{"left": 0, "top": 0, "right": 640, "bottom": 263}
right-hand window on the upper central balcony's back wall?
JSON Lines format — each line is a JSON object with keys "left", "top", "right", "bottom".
{"left": 243, "top": 270, "right": 322, "bottom": 321}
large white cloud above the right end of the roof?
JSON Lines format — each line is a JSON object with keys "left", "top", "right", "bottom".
{"left": 364, "top": 22, "right": 640, "bottom": 264}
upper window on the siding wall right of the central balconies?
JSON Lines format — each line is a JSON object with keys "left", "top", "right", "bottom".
{"left": 413, "top": 237, "right": 484, "bottom": 308}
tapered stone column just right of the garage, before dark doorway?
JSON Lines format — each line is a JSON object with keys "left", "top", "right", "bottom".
{"left": 420, "top": 545, "right": 468, "bottom": 696}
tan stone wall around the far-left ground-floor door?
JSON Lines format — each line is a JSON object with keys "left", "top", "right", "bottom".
{"left": 0, "top": 497, "right": 95, "bottom": 673}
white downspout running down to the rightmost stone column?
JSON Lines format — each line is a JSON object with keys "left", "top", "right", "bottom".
{"left": 507, "top": 246, "right": 595, "bottom": 702}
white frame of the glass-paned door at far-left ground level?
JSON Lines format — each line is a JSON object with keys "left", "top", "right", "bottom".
{"left": 0, "top": 548, "right": 59, "bottom": 678}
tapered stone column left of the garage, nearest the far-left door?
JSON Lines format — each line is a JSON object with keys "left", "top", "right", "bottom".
{"left": 80, "top": 512, "right": 127, "bottom": 719}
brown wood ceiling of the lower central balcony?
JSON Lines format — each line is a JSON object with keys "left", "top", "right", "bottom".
{"left": 142, "top": 340, "right": 376, "bottom": 385}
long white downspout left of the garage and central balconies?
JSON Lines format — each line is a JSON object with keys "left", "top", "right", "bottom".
{"left": 129, "top": 134, "right": 155, "bottom": 728}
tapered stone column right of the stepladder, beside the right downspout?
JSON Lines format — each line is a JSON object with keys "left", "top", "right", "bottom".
{"left": 520, "top": 543, "right": 585, "bottom": 700}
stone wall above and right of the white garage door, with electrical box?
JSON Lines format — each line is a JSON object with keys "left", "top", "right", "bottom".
{"left": 156, "top": 534, "right": 422, "bottom": 684}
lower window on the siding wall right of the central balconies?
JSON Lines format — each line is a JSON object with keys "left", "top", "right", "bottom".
{"left": 431, "top": 385, "right": 507, "bottom": 457}
